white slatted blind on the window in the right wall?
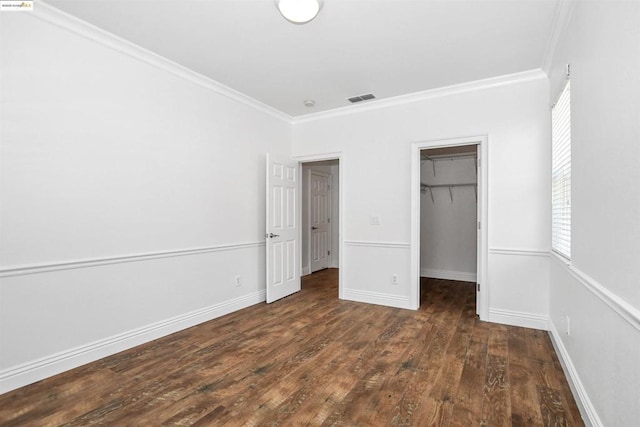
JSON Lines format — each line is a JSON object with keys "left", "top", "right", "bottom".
{"left": 551, "top": 82, "right": 571, "bottom": 258}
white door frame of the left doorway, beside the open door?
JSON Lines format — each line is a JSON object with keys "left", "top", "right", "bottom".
{"left": 292, "top": 151, "right": 346, "bottom": 299}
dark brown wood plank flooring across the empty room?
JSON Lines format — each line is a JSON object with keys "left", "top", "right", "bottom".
{"left": 0, "top": 269, "right": 583, "bottom": 426}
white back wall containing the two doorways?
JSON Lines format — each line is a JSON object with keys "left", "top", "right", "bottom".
{"left": 293, "top": 72, "right": 550, "bottom": 327}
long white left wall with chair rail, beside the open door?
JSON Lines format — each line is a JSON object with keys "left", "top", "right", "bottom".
{"left": 0, "top": 5, "right": 291, "bottom": 391}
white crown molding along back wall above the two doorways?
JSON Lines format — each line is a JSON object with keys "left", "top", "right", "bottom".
{"left": 292, "top": 69, "right": 547, "bottom": 125}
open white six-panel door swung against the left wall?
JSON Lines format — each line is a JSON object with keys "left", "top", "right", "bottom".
{"left": 266, "top": 153, "right": 300, "bottom": 303}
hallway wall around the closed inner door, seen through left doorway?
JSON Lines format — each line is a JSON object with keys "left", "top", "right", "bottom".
{"left": 301, "top": 160, "right": 340, "bottom": 275}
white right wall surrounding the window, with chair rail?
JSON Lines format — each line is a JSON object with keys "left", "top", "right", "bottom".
{"left": 549, "top": 1, "right": 640, "bottom": 426}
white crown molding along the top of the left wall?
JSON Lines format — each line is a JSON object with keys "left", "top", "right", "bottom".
{"left": 30, "top": 1, "right": 292, "bottom": 123}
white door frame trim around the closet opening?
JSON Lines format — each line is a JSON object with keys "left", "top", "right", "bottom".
{"left": 409, "top": 135, "right": 490, "bottom": 320}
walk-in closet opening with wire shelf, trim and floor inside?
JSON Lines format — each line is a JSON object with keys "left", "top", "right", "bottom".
{"left": 412, "top": 138, "right": 486, "bottom": 314}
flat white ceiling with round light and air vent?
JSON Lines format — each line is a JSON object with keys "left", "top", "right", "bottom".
{"left": 47, "top": 0, "right": 559, "bottom": 117}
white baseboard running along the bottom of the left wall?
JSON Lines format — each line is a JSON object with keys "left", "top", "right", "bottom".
{"left": 0, "top": 290, "right": 265, "bottom": 393}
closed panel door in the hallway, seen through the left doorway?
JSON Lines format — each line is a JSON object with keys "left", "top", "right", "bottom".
{"left": 309, "top": 170, "right": 331, "bottom": 273}
